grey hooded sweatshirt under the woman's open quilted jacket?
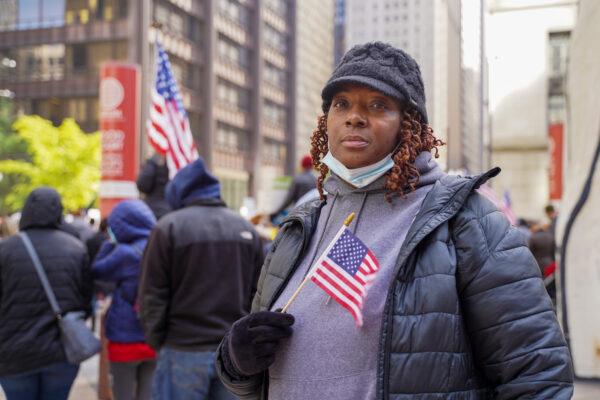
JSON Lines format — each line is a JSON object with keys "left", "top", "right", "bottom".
{"left": 269, "top": 152, "right": 444, "bottom": 400}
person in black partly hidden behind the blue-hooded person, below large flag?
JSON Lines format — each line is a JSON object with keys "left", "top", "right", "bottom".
{"left": 136, "top": 154, "right": 171, "bottom": 219}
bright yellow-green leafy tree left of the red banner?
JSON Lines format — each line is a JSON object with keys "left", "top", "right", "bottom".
{"left": 0, "top": 115, "right": 101, "bottom": 211}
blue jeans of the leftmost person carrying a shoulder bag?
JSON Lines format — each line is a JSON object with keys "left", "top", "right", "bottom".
{"left": 0, "top": 363, "right": 79, "bottom": 400}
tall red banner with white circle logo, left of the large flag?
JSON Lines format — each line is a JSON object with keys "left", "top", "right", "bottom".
{"left": 99, "top": 62, "right": 140, "bottom": 216}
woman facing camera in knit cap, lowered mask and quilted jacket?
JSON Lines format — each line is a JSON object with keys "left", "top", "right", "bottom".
{"left": 217, "top": 42, "right": 572, "bottom": 400}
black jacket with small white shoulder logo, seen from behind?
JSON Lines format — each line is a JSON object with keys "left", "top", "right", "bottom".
{"left": 138, "top": 199, "right": 263, "bottom": 351}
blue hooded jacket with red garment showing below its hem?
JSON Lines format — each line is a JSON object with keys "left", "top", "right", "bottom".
{"left": 92, "top": 200, "right": 156, "bottom": 343}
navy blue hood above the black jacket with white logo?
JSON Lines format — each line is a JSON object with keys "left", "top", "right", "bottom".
{"left": 165, "top": 158, "right": 221, "bottom": 210}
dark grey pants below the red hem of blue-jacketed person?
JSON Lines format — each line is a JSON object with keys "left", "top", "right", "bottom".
{"left": 110, "top": 360, "right": 156, "bottom": 400}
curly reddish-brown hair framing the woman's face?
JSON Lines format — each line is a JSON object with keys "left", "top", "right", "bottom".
{"left": 310, "top": 110, "right": 445, "bottom": 202}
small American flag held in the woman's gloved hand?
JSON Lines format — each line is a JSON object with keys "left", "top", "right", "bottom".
{"left": 310, "top": 226, "right": 379, "bottom": 326}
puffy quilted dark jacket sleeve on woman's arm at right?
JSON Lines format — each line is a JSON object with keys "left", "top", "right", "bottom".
{"left": 453, "top": 194, "right": 573, "bottom": 399}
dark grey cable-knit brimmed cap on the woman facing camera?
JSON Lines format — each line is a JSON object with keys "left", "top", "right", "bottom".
{"left": 321, "top": 42, "right": 428, "bottom": 123}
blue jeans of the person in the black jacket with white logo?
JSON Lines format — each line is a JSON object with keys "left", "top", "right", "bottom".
{"left": 152, "top": 348, "right": 237, "bottom": 400}
